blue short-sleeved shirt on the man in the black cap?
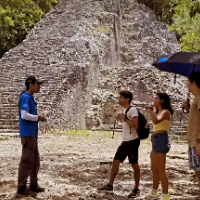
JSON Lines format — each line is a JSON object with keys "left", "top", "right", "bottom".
{"left": 19, "top": 91, "right": 38, "bottom": 137}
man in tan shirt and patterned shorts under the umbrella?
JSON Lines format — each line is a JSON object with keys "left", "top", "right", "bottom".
{"left": 184, "top": 72, "right": 200, "bottom": 194}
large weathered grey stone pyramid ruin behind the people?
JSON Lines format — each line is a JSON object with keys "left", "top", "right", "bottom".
{"left": 0, "top": 0, "right": 187, "bottom": 134}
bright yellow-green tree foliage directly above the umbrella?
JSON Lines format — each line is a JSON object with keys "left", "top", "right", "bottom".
{"left": 169, "top": 0, "right": 200, "bottom": 51}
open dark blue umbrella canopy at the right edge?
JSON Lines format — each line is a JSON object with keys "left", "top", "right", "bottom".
{"left": 152, "top": 52, "right": 200, "bottom": 76}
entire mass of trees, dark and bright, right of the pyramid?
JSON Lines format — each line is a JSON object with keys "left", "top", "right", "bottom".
{"left": 138, "top": 0, "right": 200, "bottom": 51}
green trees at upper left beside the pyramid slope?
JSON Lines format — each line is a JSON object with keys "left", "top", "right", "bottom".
{"left": 0, "top": 0, "right": 57, "bottom": 57}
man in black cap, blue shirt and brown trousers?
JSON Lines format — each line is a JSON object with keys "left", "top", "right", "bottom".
{"left": 16, "top": 76, "right": 46, "bottom": 197}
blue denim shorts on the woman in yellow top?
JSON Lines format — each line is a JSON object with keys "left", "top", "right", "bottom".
{"left": 151, "top": 133, "right": 171, "bottom": 154}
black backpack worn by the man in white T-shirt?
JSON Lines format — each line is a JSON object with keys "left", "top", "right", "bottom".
{"left": 125, "top": 106, "right": 150, "bottom": 140}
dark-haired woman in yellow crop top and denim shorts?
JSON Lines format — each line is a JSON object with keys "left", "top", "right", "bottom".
{"left": 145, "top": 93, "right": 173, "bottom": 200}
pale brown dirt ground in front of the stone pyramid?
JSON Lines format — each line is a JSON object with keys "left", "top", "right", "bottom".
{"left": 0, "top": 132, "right": 199, "bottom": 200}
